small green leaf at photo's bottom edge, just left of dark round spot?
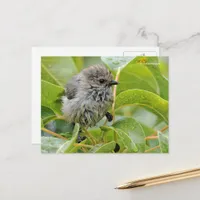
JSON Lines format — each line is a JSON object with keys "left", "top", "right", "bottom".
{"left": 89, "top": 141, "right": 116, "bottom": 153}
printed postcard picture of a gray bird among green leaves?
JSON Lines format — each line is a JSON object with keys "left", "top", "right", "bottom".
{"left": 41, "top": 56, "right": 169, "bottom": 154}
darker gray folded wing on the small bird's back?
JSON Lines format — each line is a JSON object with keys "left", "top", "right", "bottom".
{"left": 66, "top": 75, "right": 80, "bottom": 99}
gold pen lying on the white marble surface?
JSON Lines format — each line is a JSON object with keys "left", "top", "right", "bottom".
{"left": 115, "top": 168, "right": 200, "bottom": 189}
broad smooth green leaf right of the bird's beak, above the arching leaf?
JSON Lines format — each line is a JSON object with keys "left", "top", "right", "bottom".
{"left": 117, "top": 59, "right": 159, "bottom": 94}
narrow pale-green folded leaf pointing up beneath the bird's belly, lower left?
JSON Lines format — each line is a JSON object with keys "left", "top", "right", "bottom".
{"left": 57, "top": 123, "right": 80, "bottom": 153}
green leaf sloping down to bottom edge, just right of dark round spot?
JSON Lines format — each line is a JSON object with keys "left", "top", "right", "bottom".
{"left": 116, "top": 129, "right": 138, "bottom": 153}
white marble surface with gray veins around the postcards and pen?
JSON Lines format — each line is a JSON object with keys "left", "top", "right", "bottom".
{"left": 0, "top": 0, "right": 200, "bottom": 200}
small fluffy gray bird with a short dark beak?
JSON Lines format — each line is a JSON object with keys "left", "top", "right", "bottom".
{"left": 62, "top": 65, "right": 118, "bottom": 128}
